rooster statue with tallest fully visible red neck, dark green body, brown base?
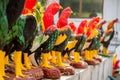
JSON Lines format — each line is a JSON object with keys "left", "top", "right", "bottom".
{"left": 33, "top": 2, "right": 62, "bottom": 79}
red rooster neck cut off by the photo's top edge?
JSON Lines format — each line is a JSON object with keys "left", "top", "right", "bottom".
{"left": 22, "top": 0, "right": 37, "bottom": 15}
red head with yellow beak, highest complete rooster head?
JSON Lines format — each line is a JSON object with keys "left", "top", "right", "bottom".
{"left": 46, "top": 2, "right": 62, "bottom": 15}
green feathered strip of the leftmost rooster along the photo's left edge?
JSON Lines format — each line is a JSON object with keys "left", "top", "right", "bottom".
{"left": 0, "top": 0, "right": 8, "bottom": 49}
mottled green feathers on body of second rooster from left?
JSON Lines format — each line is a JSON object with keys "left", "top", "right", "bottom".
{"left": 6, "top": 17, "right": 26, "bottom": 45}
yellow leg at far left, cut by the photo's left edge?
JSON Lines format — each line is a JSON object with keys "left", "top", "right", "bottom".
{"left": 0, "top": 50, "right": 9, "bottom": 80}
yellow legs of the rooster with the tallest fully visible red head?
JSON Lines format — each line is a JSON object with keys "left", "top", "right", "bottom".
{"left": 40, "top": 53, "right": 53, "bottom": 68}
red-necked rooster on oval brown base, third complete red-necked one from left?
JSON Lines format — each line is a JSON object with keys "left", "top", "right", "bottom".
{"left": 70, "top": 20, "right": 88, "bottom": 68}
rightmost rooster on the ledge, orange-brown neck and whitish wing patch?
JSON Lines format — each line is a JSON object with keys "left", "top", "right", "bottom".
{"left": 101, "top": 18, "right": 118, "bottom": 55}
